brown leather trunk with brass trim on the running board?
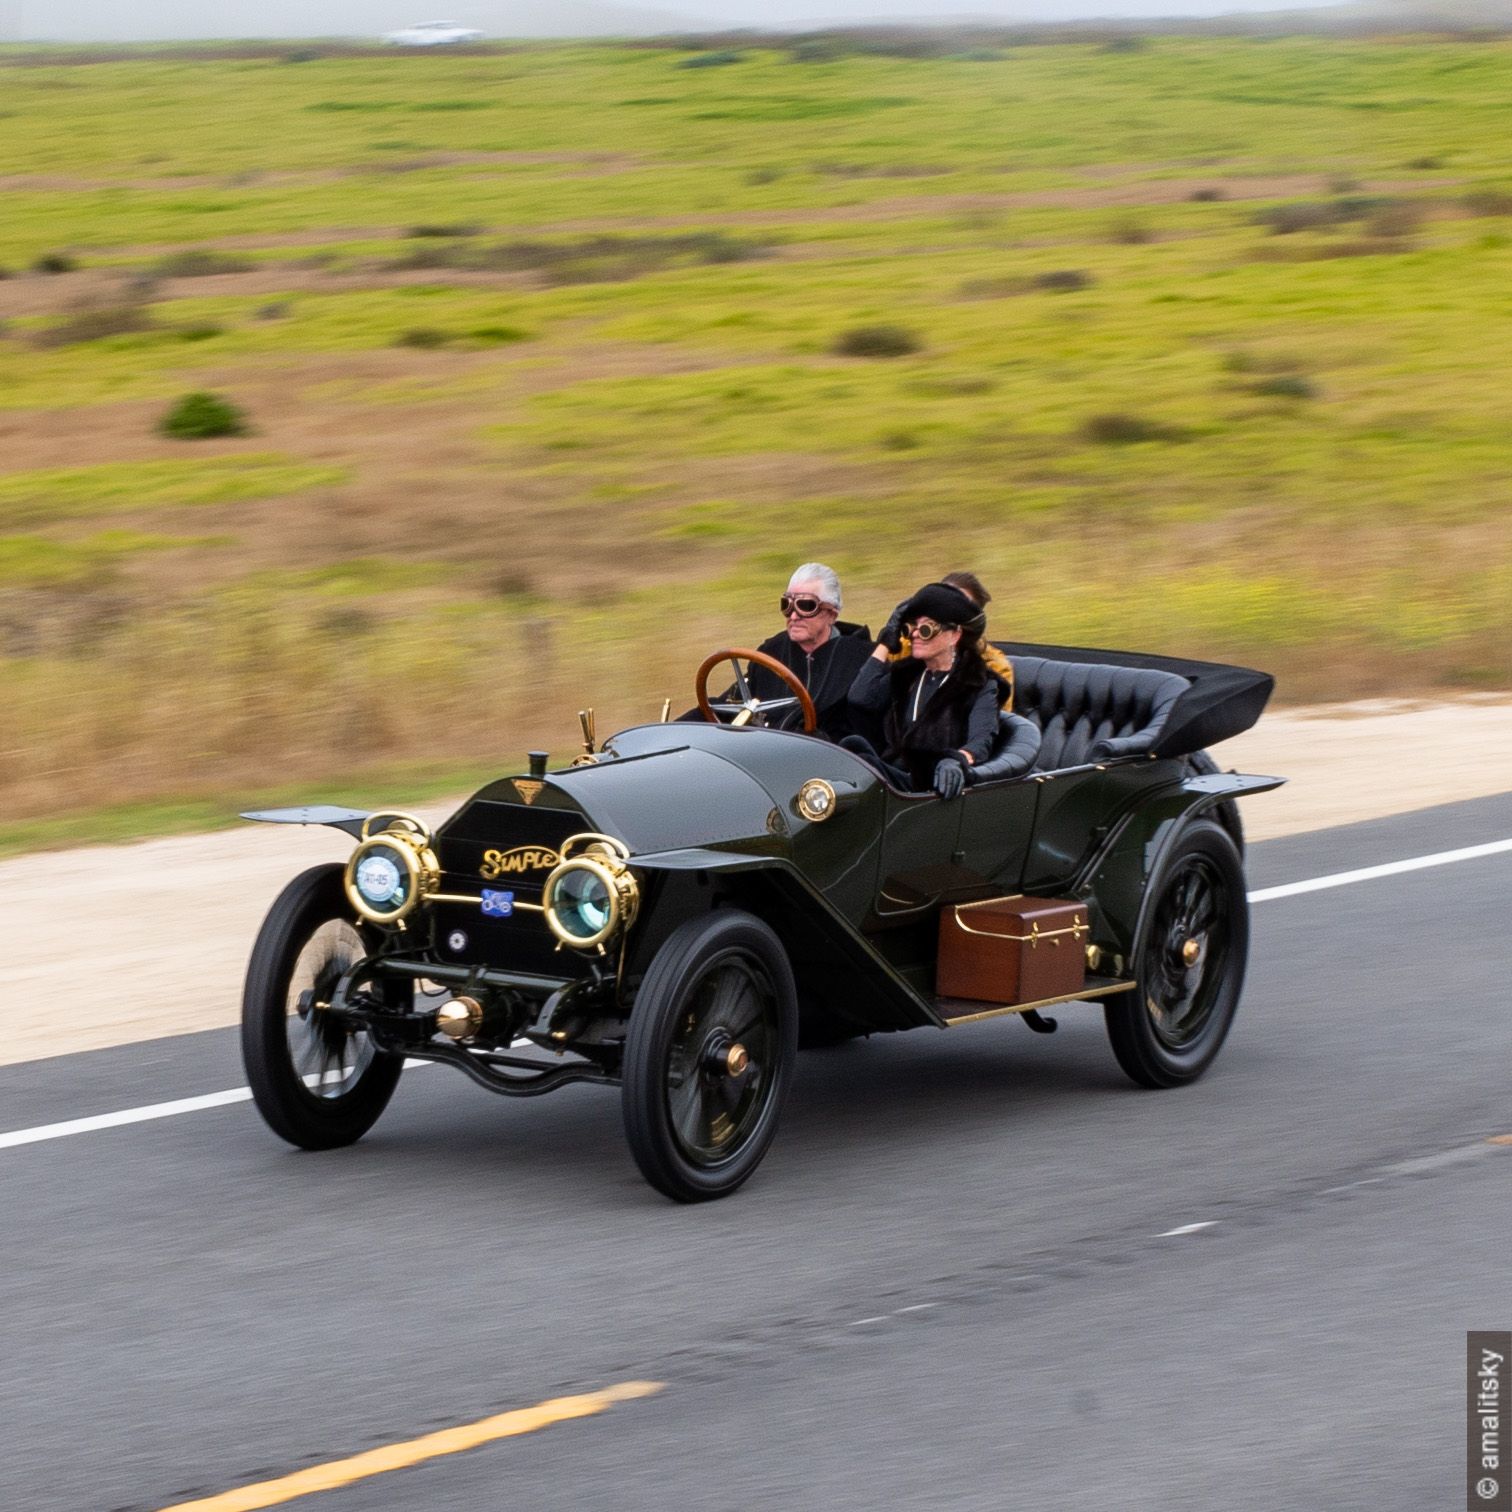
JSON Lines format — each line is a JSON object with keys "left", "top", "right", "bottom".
{"left": 934, "top": 895, "right": 1089, "bottom": 1004}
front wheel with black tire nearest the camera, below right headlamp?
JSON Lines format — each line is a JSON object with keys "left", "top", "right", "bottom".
{"left": 621, "top": 909, "right": 798, "bottom": 1202}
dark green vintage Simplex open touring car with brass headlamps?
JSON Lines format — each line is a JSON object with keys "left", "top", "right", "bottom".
{"left": 242, "top": 643, "right": 1282, "bottom": 1202}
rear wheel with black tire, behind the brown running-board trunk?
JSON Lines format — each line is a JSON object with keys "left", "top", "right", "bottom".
{"left": 1102, "top": 820, "right": 1249, "bottom": 1087}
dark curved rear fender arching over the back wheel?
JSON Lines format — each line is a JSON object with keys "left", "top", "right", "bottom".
{"left": 1075, "top": 771, "right": 1287, "bottom": 971}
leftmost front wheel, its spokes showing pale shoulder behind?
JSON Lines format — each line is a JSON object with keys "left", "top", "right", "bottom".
{"left": 242, "top": 863, "right": 404, "bottom": 1149}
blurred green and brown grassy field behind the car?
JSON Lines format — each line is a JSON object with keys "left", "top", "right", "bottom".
{"left": 0, "top": 38, "right": 1512, "bottom": 845}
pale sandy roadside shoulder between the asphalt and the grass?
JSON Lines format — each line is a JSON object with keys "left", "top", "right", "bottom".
{"left": 0, "top": 697, "right": 1512, "bottom": 1064}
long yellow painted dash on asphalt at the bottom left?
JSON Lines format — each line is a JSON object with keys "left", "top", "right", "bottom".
{"left": 162, "top": 1380, "right": 662, "bottom": 1512}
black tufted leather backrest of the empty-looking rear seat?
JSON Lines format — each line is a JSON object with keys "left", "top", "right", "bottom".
{"left": 1013, "top": 656, "right": 1188, "bottom": 771}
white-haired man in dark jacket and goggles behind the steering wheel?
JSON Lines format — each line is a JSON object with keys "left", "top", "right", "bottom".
{"left": 680, "top": 562, "right": 872, "bottom": 741}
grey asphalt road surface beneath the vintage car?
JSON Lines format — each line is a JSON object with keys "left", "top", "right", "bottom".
{"left": 0, "top": 795, "right": 1512, "bottom": 1512}
